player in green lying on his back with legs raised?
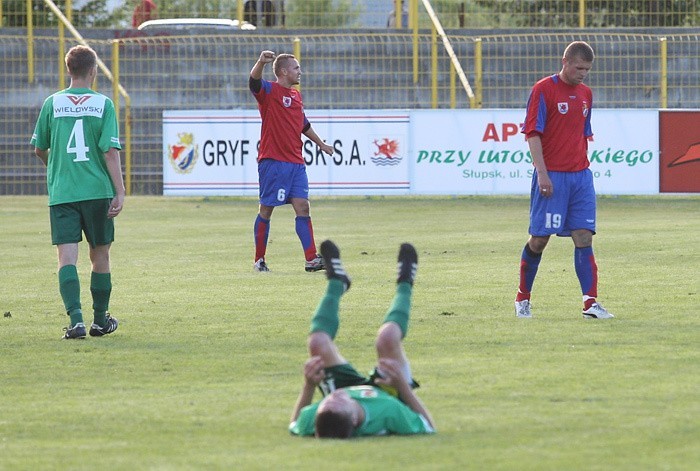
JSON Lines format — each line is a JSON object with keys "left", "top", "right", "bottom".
{"left": 289, "top": 240, "right": 435, "bottom": 438}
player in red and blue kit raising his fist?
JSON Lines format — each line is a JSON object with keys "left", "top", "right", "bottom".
{"left": 249, "top": 51, "right": 334, "bottom": 272}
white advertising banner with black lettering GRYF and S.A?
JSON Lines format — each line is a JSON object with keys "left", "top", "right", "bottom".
{"left": 163, "top": 110, "right": 410, "bottom": 196}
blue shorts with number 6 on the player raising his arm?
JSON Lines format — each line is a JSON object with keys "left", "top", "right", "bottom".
{"left": 258, "top": 159, "right": 309, "bottom": 206}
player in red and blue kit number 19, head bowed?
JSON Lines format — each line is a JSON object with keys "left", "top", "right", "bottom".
{"left": 515, "top": 41, "right": 614, "bottom": 319}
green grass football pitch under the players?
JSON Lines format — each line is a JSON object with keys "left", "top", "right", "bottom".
{"left": 0, "top": 196, "right": 700, "bottom": 470}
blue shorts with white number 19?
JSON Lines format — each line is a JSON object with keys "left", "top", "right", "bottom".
{"left": 529, "top": 169, "right": 596, "bottom": 237}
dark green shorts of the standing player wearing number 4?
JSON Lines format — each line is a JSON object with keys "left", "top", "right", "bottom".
{"left": 49, "top": 199, "right": 114, "bottom": 248}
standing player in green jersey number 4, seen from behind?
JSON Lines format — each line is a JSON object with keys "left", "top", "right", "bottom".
{"left": 31, "top": 46, "right": 126, "bottom": 339}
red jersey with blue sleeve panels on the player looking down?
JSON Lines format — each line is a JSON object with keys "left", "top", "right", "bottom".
{"left": 522, "top": 75, "right": 593, "bottom": 172}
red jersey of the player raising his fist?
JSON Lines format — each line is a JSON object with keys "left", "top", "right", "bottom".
{"left": 253, "top": 80, "right": 309, "bottom": 164}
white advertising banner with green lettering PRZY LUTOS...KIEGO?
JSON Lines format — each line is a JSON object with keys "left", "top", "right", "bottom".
{"left": 411, "top": 110, "right": 659, "bottom": 195}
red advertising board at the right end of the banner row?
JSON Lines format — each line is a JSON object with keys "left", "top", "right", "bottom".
{"left": 659, "top": 111, "right": 700, "bottom": 193}
